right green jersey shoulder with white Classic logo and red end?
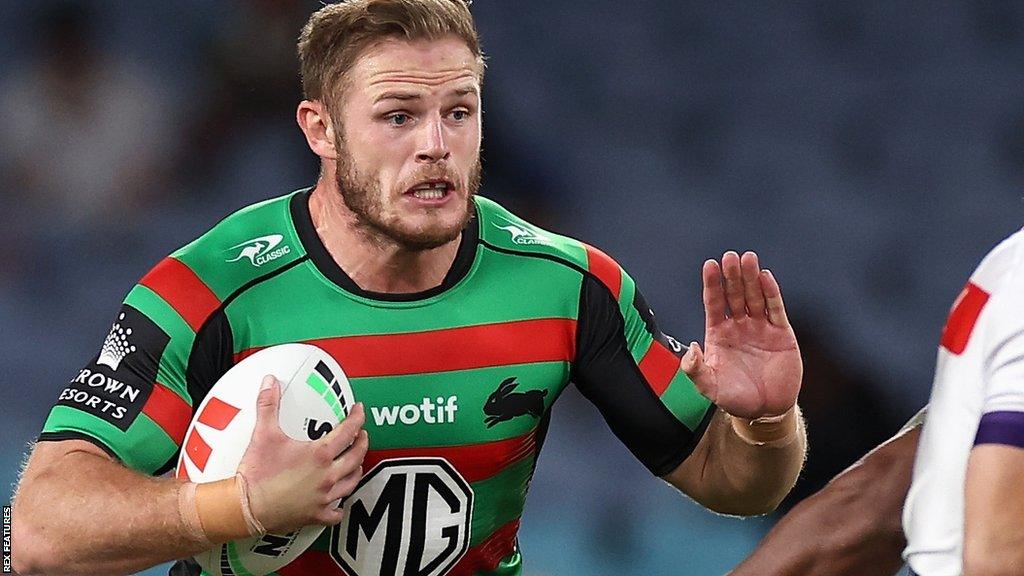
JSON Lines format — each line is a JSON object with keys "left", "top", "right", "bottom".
{"left": 475, "top": 196, "right": 625, "bottom": 295}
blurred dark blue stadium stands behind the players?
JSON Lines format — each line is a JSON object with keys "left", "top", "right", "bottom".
{"left": 0, "top": 0, "right": 1024, "bottom": 575}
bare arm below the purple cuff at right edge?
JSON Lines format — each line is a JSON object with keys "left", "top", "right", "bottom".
{"left": 964, "top": 444, "right": 1024, "bottom": 576}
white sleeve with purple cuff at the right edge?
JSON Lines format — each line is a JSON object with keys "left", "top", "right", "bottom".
{"left": 968, "top": 273, "right": 1024, "bottom": 448}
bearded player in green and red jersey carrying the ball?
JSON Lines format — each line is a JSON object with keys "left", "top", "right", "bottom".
{"left": 13, "top": 0, "right": 805, "bottom": 576}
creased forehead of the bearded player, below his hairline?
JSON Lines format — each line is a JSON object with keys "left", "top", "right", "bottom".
{"left": 349, "top": 36, "right": 479, "bottom": 92}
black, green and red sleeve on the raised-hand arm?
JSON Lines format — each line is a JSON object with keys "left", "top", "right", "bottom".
{"left": 571, "top": 251, "right": 715, "bottom": 476}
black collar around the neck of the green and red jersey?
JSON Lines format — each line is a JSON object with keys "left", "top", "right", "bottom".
{"left": 291, "top": 189, "right": 480, "bottom": 302}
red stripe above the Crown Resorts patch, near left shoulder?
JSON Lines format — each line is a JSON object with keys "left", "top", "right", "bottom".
{"left": 138, "top": 256, "right": 220, "bottom": 332}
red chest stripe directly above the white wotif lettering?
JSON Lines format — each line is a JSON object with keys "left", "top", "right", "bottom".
{"left": 234, "top": 318, "right": 577, "bottom": 378}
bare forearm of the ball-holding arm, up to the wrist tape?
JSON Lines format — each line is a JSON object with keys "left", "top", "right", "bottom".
{"left": 12, "top": 452, "right": 206, "bottom": 574}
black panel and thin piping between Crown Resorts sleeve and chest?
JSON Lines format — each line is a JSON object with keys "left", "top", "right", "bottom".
{"left": 185, "top": 256, "right": 309, "bottom": 407}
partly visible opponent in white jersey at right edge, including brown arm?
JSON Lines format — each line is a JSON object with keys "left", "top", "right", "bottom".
{"left": 731, "top": 226, "right": 1024, "bottom": 576}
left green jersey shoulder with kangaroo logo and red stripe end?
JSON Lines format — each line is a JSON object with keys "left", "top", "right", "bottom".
{"left": 139, "top": 192, "right": 305, "bottom": 329}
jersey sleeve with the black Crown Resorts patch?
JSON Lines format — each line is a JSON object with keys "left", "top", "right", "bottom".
{"left": 39, "top": 257, "right": 232, "bottom": 475}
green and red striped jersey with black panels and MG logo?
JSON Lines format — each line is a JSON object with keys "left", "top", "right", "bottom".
{"left": 40, "top": 191, "right": 714, "bottom": 576}
